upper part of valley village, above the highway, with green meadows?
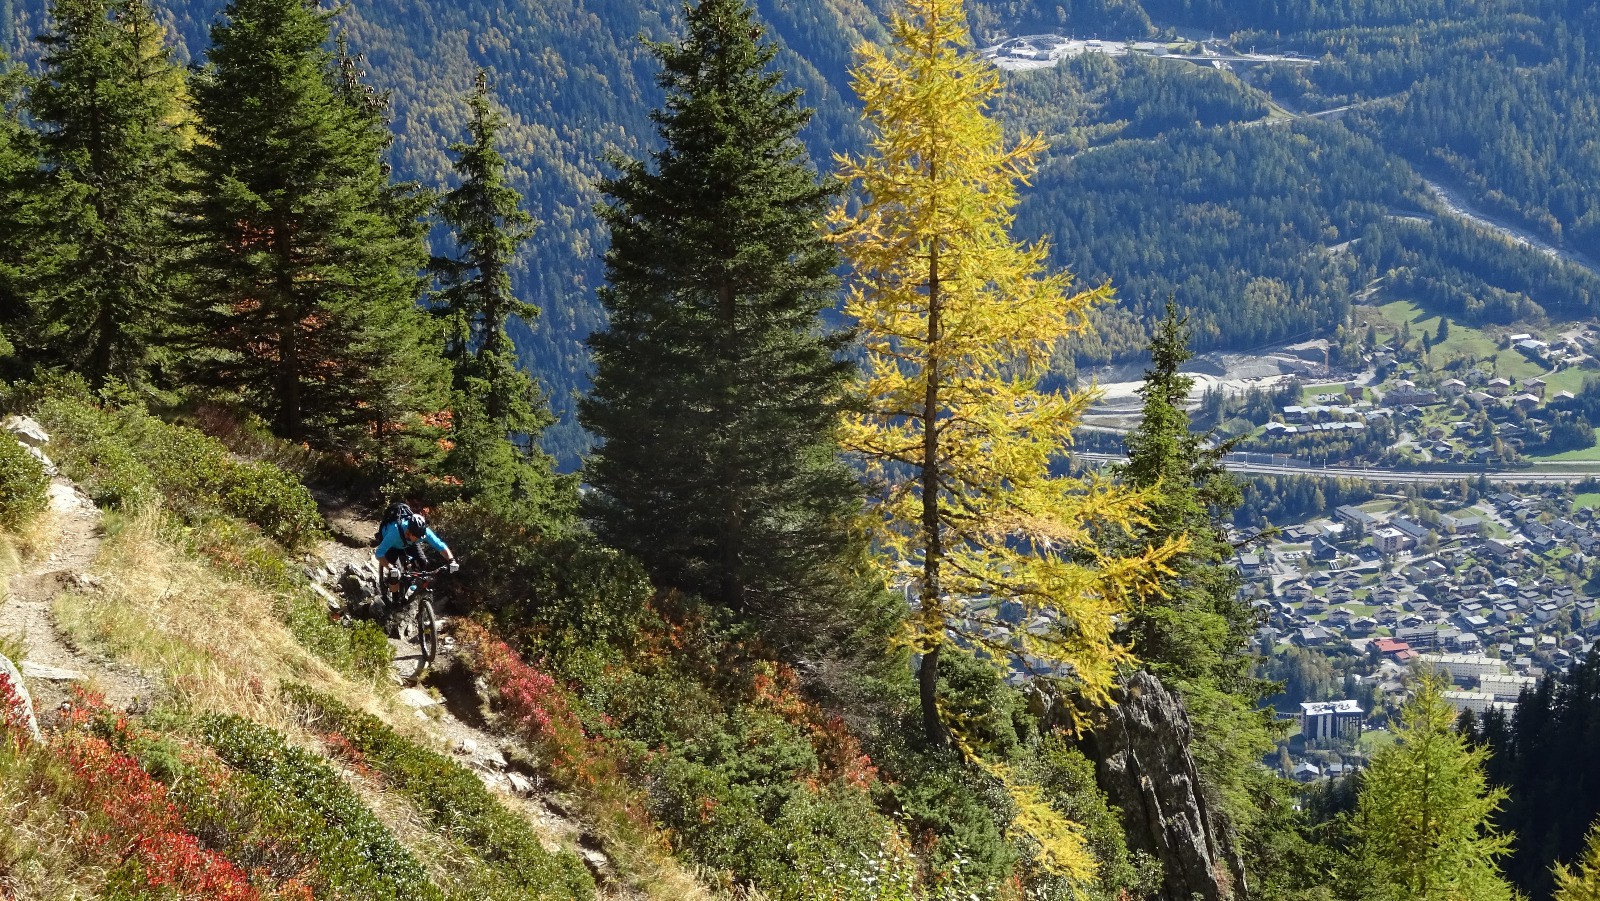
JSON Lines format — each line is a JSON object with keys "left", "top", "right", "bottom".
{"left": 1213, "top": 304, "right": 1600, "bottom": 471}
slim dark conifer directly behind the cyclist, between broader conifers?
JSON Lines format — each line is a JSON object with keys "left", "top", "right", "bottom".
{"left": 432, "top": 70, "right": 568, "bottom": 519}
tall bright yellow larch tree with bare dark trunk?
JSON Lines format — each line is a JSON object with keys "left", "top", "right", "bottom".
{"left": 834, "top": 0, "right": 1174, "bottom": 746}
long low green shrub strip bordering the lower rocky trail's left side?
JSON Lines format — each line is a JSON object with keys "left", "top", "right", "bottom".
{"left": 290, "top": 687, "right": 595, "bottom": 901}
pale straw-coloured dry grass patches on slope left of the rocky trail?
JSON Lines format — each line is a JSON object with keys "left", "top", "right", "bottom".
{"left": 0, "top": 499, "right": 702, "bottom": 901}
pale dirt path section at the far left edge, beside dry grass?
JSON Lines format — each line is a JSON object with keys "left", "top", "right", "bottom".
{"left": 0, "top": 475, "right": 152, "bottom": 714}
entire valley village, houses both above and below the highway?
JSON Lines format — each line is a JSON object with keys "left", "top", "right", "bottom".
{"left": 1082, "top": 301, "right": 1600, "bottom": 781}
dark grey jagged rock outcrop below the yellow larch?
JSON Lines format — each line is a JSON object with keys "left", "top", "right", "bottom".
{"left": 1083, "top": 672, "right": 1248, "bottom": 901}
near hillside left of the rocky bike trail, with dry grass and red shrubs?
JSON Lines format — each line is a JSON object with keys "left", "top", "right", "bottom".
{"left": 0, "top": 402, "right": 675, "bottom": 901}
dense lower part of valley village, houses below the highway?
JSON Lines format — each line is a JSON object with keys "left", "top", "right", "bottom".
{"left": 1237, "top": 488, "right": 1600, "bottom": 779}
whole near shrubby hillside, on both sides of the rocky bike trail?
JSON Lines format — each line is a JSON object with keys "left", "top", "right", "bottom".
{"left": 0, "top": 384, "right": 1177, "bottom": 901}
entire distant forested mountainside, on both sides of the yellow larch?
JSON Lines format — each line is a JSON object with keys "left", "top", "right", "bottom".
{"left": 8, "top": 0, "right": 1600, "bottom": 464}
